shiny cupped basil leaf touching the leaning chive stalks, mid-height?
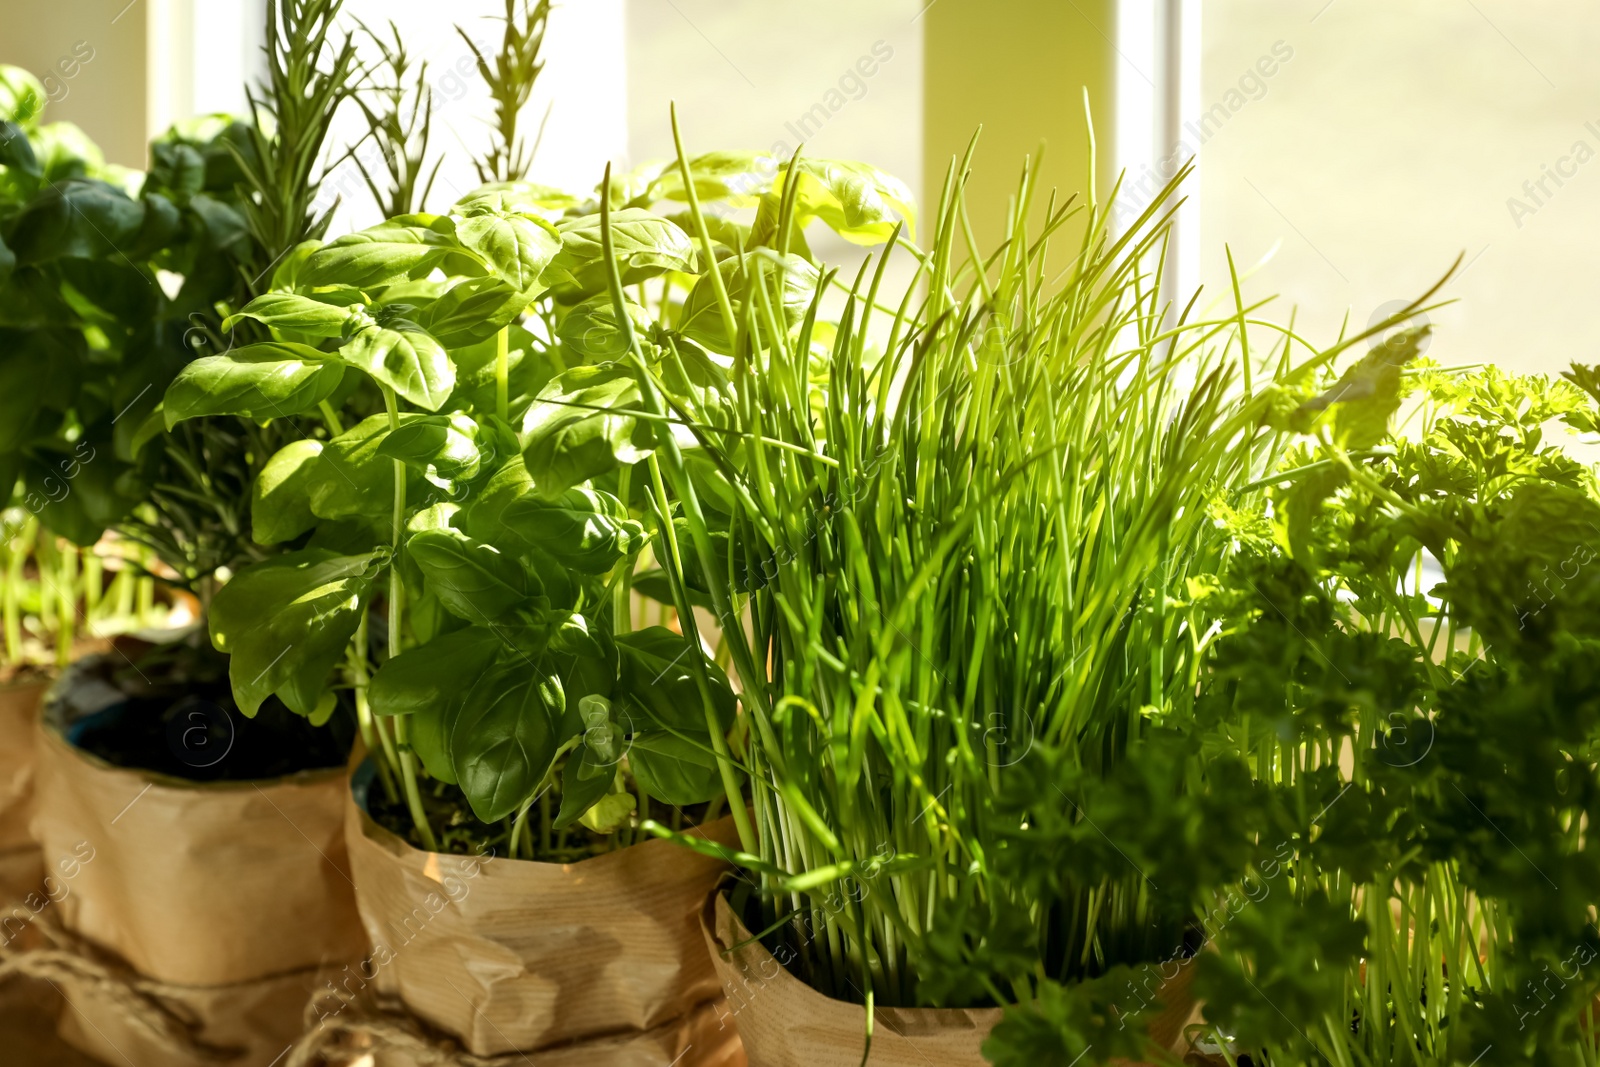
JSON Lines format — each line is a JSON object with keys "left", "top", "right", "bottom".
{"left": 522, "top": 365, "right": 654, "bottom": 496}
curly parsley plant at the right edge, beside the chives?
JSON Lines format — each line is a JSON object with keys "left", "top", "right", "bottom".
{"left": 1197, "top": 355, "right": 1600, "bottom": 1064}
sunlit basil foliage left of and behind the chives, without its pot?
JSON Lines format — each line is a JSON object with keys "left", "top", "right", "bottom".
{"left": 172, "top": 143, "right": 909, "bottom": 854}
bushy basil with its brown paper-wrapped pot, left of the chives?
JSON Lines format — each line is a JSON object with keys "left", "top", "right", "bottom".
{"left": 206, "top": 167, "right": 755, "bottom": 1062}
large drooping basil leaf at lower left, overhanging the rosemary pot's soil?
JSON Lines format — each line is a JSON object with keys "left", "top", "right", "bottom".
{"left": 210, "top": 549, "right": 378, "bottom": 717}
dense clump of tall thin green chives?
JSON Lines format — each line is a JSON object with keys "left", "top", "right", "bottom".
{"left": 624, "top": 125, "right": 1452, "bottom": 1062}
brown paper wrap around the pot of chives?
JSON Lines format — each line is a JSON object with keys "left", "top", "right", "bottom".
{"left": 701, "top": 889, "right": 1194, "bottom": 1067}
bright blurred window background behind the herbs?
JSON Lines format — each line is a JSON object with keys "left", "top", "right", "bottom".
{"left": 0, "top": 0, "right": 1600, "bottom": 371}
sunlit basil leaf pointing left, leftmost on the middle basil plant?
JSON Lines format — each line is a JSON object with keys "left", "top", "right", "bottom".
{"left": 165, "top": 341, "right": 344, "bottom": 429}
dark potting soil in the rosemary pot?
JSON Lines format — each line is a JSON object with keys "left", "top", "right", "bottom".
{"left": 67, "top": 645, "right": 355, "bottom": 782}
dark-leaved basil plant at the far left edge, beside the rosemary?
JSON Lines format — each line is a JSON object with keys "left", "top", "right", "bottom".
{"left": 0, "top": 67, "right": 248, "bottom": 545}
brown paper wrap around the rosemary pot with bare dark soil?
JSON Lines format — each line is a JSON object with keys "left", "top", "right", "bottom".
{"left": 32, "top": 669, "right": 366, "bottom": 1067}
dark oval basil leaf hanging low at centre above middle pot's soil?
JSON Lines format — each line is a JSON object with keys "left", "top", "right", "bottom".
{"left": 450, "top": 656, "right": 566, "bottom": 822}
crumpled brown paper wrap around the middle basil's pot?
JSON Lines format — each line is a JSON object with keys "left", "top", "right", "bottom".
{"left": 346, "top": 766, "right": 736, "bottom": 1067}
